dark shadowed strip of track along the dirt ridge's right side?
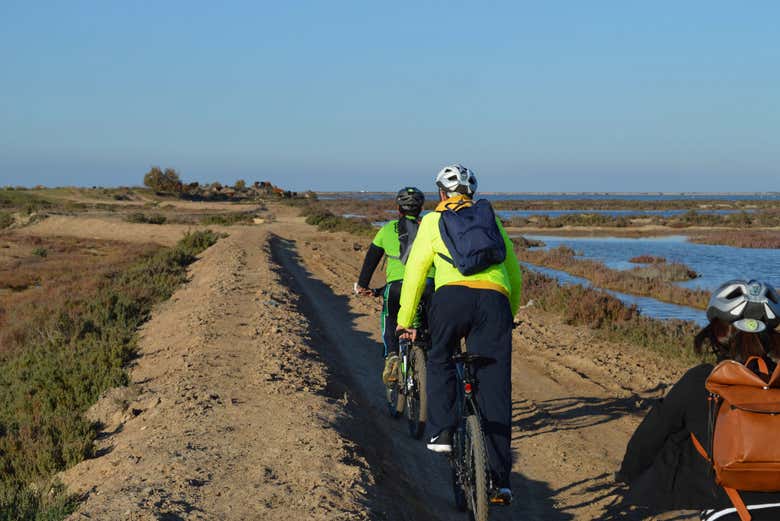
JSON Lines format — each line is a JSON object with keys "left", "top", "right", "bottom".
{"left": 271, "top": 237, "right": 459, "bottom": 521}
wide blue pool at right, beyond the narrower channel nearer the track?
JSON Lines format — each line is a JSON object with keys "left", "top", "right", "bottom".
{"left": 527, "top": 235, "right": 780, "bottom": 291}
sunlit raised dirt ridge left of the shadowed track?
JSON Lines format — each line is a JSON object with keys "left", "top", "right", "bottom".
{"left": 63, "top": 228, "right": 392, "bottom": 521}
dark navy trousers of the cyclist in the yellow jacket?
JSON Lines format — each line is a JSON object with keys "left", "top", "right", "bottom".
{"left": 428, "top": 286, "right": 512, "bottom": 487}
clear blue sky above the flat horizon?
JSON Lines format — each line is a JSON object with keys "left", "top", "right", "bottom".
{"left": 0, "top": 0, "right": 780, "bottom": 191}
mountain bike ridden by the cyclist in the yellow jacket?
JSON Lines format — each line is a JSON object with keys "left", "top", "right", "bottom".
{"left": 450, "top": 353, "right": 506, "bottom": 521}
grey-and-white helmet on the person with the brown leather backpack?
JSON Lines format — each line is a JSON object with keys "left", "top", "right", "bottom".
{"left": 707, "top": 280, "right": 780, "bottom": 333}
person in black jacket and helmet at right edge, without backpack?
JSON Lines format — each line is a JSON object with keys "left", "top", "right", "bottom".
{"left": 616, "top": 281, "right": 780, "bottom": 521}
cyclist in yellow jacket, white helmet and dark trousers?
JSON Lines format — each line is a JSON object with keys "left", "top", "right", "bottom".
{"left": 398, "top": 165, "right": 521, "bottom": 502}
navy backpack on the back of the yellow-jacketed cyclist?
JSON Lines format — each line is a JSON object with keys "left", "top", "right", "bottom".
{"left": 439, "top": 199, "right": 506, "bottom": 275}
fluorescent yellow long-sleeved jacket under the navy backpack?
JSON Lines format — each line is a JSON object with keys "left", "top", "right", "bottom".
{"left": 398, "top": 195, "right": 522, "bottom": 327}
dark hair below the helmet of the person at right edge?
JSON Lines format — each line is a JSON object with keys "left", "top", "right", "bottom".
{"left": 693, "top": 318, "right": 780, "bottom": 363}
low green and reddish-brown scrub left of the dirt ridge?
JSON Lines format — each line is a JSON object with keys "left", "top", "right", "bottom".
{"left": 0, "top": 230, "right": 218, "bottom": 521}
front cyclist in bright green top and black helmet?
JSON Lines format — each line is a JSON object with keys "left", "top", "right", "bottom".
{"left": 355, "top": 186, "right": 432, "bottom": 385}
